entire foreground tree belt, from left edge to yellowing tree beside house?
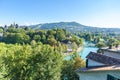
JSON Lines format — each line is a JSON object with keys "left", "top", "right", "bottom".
{"left": 0, "top": 43, "right": 85, "bottom": 80}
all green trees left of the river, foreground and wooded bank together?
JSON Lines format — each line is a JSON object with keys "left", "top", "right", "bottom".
{"left": 0, "top": 24, "right": 84, "bottom": 80}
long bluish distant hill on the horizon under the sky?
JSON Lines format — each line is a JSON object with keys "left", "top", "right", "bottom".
{"left": 27, "top": 22, "right": 120, "bottom": 33}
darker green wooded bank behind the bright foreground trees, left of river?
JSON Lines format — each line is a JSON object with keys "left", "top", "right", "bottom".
{"left": 2, "top": 27, "right": 83, "bottom": 46}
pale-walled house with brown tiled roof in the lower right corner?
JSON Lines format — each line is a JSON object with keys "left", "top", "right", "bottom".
{"left": 76, "top": 52, "right": 120, "bottom": 80}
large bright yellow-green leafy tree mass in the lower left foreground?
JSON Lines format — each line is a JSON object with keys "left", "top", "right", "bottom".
{"left": 0, "top": 44, "right": 62, "bottom": 80}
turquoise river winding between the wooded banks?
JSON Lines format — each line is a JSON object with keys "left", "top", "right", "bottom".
{"left": 64, "top": 43, "right": 98, "bottom": 60}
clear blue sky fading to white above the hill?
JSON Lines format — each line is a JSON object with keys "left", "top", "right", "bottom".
{"left": 0, "top": 0, "right": 120, "bottom": 28}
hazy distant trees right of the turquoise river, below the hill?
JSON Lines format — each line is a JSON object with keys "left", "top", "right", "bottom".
{"left": 76, "top": 32, "right": 120, "bottom": 48}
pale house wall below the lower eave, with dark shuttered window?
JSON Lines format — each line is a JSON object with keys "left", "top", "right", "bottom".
{"left": 78, "top": 68, "right": 120, "bottom": 80}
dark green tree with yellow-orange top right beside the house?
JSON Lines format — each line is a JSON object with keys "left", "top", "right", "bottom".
{"left": 61, "top": 53, "right": 85, "bottom": 80}
